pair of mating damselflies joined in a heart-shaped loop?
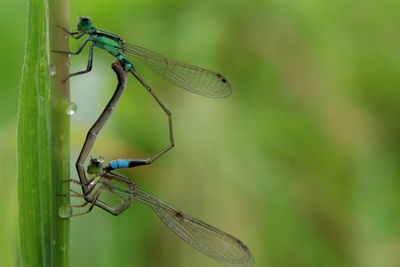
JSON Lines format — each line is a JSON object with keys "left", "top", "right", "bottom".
{"left": 54, "top": 17, "right": 253, "bottom": 266}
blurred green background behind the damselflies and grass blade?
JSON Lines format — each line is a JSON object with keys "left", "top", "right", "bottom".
{"left": 0, "top": 0, "right": 400, "bottom": 267}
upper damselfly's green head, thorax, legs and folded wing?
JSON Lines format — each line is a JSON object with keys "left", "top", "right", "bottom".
{"left": 55, "top": 17, "right": 232, "bottom": 97}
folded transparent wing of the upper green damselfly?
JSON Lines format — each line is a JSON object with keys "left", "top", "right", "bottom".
{"left": 122, "top": 43, "right": 232, "bottom": 97}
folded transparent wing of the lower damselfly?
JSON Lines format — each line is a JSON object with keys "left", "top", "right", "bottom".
{"left": 134, "top": 187, "right": 253, "bottom": 267}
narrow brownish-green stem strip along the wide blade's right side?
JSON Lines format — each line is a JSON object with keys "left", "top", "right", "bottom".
{"left": 49, "top": 0, "right": 70, "bottom": 266}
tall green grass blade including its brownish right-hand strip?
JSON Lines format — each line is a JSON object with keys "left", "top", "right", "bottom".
{"left": 17, "top": 0, "right": 69, "bottom": 267}
